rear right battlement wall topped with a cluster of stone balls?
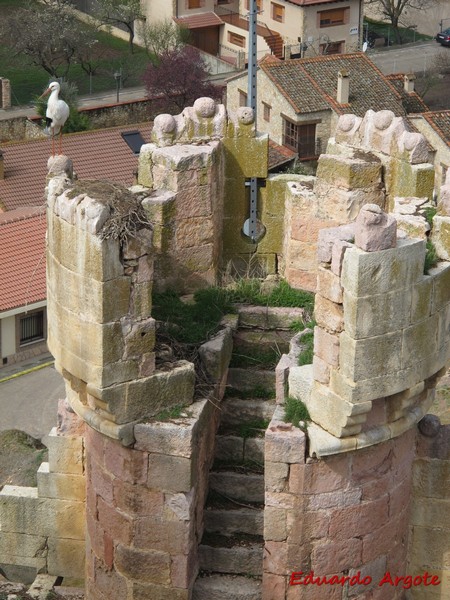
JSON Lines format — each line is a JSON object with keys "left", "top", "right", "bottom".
{"left": 279, "top": 111, "right": 434, "bottom": 291}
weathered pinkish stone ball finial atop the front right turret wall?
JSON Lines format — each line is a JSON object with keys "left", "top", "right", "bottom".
{"left": 355, "top": 204, "right": 397, "bottom": 252}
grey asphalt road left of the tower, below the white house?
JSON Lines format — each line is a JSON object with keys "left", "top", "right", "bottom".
{"left": 0, "top": 366, "right": 66, "bottom": 439}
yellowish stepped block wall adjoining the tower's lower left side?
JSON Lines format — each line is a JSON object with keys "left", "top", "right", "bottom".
{"left": 0, "top": 428, "right": 86, "bottom": 582}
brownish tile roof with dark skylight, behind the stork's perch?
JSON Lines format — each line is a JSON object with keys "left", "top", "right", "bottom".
{"left": 0, "top": 123, "right": 151, "bottom": 211}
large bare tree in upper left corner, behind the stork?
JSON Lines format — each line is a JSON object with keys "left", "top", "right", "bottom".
{"left": 1, "top": 0, "right": 86, "bottom": 77}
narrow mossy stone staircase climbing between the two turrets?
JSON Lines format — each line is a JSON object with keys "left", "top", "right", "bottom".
{"left": 193, "top": 307, "right": 304, "bottom": 600}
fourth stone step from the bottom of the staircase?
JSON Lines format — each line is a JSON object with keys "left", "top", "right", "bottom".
{"left": 209, "top": 471, "right": 264, "bottom": 504}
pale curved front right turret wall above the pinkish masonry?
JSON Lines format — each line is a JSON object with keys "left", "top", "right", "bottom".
{"left": 289, "top": 228, "right": 450, "bottom": 455}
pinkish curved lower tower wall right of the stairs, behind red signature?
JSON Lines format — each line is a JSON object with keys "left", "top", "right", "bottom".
{"left": 263, "top": 406, "right": 415, "bottom": 600}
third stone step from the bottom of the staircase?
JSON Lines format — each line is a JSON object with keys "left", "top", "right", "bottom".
{"left": 204, "top": 508, "right": 264, "bottom": 535}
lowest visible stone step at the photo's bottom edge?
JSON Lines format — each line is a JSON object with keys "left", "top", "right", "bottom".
{"left": 192, "top": 573, "right": 262, "bottom": 600}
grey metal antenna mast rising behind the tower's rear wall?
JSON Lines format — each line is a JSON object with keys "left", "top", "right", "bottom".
{"left": 242, "top": 0, "right": 266, "bottom": 244}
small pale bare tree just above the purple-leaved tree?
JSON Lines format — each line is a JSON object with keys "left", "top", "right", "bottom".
{"left": 141, "top": 19, "right": 190, "bottom": 64}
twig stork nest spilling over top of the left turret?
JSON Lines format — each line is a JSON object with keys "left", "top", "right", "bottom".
{"left": 66, "top": 179, "right": 152, "bottom": 245}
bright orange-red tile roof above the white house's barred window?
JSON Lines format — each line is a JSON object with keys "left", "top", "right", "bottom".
{"left": 0, "top": 208, "right": 47, "bottom": 311}
